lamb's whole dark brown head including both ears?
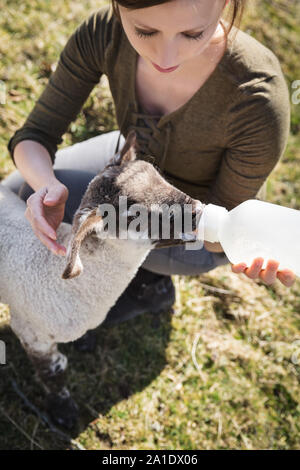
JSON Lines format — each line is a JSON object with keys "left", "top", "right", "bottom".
{"left": 62, "top": 130, "right": 204, "bottom": 279}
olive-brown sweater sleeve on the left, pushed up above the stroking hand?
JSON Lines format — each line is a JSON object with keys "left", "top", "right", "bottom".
{"left": 8, "top": 8, "right": 109, "bottom": 164}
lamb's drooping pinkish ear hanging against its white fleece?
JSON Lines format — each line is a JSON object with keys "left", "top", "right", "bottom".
{"left": 61, "top": 207, "right": 103, "bottom": 279}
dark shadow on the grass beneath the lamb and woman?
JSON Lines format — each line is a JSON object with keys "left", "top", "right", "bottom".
{"left": 0, "top": 311, "right": 172, "bottom": 450}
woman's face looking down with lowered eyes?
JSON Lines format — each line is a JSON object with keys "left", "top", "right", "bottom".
{"left": 119, "top": 0, "right": 228, "bottom": 75}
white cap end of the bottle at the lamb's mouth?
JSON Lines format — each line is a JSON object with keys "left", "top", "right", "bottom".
{"left": 199, "top": 204, "right": 228, "bottom": 243}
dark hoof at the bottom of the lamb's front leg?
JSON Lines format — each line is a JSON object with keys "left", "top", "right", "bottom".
{"left": 46, "top": 393, "right": 79, "bottom": 429}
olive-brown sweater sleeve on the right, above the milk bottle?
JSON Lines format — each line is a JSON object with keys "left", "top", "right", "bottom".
{"left": 207, "top": 74, "right": 290, "bottom": 210}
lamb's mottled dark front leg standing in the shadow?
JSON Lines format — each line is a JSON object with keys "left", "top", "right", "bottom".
{"left": 21, "top": 340, "right": 78, "bottom": 429}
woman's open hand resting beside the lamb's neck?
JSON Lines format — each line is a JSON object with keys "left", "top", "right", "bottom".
{"left": 25, "top": 181, "right": 69, "bottom": 256}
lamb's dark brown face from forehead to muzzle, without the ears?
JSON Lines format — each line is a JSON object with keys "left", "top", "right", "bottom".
{"left": 112, "top": 160, "right": 202, "bottom": 247}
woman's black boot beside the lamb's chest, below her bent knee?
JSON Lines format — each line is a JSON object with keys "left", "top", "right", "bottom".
{"left": 102, "top": 267, "right": 175, "bottom": 326}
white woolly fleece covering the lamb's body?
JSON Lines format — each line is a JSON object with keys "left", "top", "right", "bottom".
{"left": 0, "top": 184, "right": 153, "bottom": 351}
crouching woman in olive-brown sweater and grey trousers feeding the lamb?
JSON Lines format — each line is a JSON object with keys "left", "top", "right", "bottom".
{"left": 4, "top": 0, "right": 295, "bottom": 330}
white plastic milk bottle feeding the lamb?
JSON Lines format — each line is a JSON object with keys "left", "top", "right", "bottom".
{"left": 199, "top": 199, "right": 300, "bottom": 277}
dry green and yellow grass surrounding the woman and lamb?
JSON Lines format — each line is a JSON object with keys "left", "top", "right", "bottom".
{"left": 0, "top": 0, "right": 300, "bottom": 450}
